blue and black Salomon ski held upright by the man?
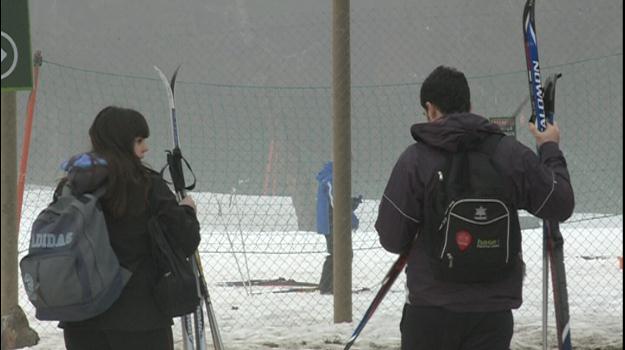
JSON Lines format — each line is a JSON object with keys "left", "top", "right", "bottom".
{"left": 523, "top": 0, "right": 572, "bottom": 350}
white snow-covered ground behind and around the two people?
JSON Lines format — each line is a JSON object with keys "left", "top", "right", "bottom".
{"left": 20, "top": 187, "right": 623, "bottom": 350}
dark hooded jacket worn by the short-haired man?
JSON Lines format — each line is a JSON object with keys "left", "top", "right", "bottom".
{"left": 375, "top": 114, "right": 574, "bottom": 312}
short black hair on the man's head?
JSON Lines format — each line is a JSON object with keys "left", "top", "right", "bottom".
{"left": 421, "top": 66, "right": 471, "bottom": 114}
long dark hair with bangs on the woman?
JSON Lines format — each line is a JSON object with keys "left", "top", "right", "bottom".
{"left": 89, "top": 106, "right": 150, "bottom": 217}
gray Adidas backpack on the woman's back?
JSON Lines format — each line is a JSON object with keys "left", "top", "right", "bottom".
{"left": 20, "top": 185, "right": 132, "bottom": 321}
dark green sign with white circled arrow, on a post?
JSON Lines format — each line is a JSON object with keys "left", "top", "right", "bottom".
{"left": 0, "top": 0, "right": 33, "bottom": 91}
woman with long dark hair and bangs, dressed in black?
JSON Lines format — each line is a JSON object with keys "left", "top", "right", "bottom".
{"left": 57, "top": 106, "right": 200, "bottom": 350}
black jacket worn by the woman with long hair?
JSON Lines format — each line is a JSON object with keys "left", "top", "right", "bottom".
{"left": 59, "top": 165, "right": 200, "bottom": 331}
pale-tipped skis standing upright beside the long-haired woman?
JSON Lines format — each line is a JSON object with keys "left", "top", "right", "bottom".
{"left": 154, "top": 66, "right": 224, "bottom": 350}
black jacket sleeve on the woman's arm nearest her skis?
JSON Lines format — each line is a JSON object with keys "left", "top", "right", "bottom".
{"left": 150, "top": 176, "right": 200, "bottom": 256}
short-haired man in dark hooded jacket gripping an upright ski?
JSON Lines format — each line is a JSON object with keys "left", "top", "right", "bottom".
{"left": 375, "top": 66, "right": 574, "bottom": 350}
